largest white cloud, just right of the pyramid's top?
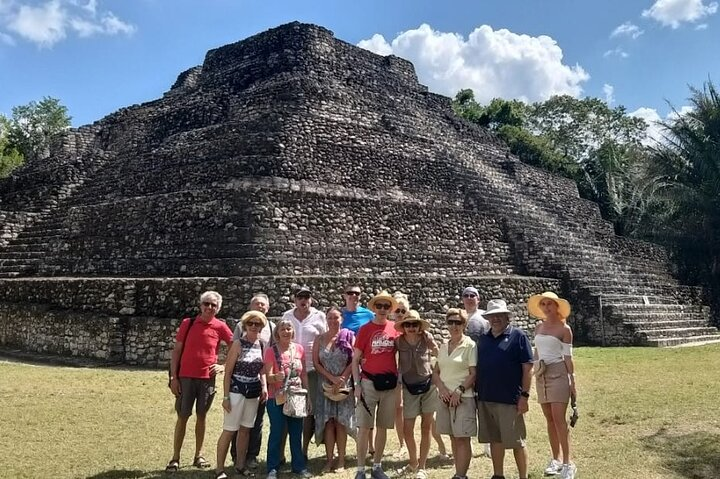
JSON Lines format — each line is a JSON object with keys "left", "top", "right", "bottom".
{"left": 358, "top": 24, "right": 590, "bottom": 102}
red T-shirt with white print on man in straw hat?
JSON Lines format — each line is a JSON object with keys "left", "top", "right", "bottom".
{"left": 355, "top": 321, "right": 400, "bottom": 378}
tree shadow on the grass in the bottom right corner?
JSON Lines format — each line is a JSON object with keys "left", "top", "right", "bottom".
{"left": 645, "top": 428, "right": 720, "bottom": 479}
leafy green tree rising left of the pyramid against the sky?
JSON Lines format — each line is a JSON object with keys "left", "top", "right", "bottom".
{"left": 8, "top": 97, "right": 70, "bottom": 161}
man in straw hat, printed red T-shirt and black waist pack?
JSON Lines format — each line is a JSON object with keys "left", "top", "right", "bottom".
{"left": 352, "top": 291, "right": 399, "bottom": 479}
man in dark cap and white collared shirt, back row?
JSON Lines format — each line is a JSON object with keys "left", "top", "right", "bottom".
{"left": 282, "top": 286, "right": 327, "bottom": 457}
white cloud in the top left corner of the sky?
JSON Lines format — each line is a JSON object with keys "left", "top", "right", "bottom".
{"left": 0, "top": 0, "right": 135, "bottom": 47}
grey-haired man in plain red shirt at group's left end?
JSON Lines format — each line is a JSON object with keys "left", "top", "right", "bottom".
{"left": 165, "top": 291, "right": 232, "bottom": 471}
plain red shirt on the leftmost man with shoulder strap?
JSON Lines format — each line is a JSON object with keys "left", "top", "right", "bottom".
{"left": 175, "top": 316, "right": 232, "bottom": 379}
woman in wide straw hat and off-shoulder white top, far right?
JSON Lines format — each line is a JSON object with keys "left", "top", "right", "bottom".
{"left": 528, "top": 291, "right": 576, "bottom": 479}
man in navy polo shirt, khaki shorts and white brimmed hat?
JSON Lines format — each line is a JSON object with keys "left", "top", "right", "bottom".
{"left": 475, "top": 299, "right": 533, "bottom": 479}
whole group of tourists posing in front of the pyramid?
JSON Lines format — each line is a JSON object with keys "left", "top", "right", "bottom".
{"left": 166, "top": 285, "right": 576, "bottom": 479}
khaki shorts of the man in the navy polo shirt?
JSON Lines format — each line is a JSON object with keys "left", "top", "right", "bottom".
{"left": 478, "top": 401, "right": 527, "bottom": 449}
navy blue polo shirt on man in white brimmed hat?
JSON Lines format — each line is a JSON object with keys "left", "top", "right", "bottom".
{"left": 475, "top": 326, "right": 533, "bottom": 404}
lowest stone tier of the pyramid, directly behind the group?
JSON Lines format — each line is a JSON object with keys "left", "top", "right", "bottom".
{"left": 0, "top": 276, "right": 561, "bottom": 366}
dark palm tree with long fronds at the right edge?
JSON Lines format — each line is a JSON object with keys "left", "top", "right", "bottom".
{"left": 648, "top": 81, "right": 720, "bottom": 282}
